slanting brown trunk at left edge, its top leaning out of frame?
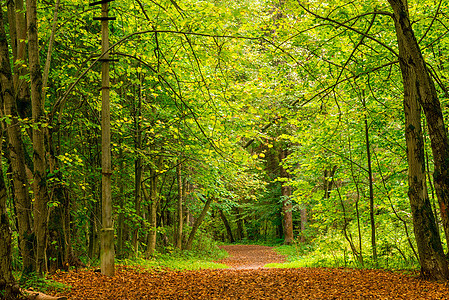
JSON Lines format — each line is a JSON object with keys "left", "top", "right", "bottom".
{"left": 0, "top": 5, "right": 35, "bottom": 274}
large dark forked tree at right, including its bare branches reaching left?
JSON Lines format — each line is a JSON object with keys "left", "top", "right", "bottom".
{"left": 290, "top": 1, "right": 449, "bottom": 279}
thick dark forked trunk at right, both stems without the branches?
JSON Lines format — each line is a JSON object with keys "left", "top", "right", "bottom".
{"left": 388, "top": 0, "right": 449, "bottom": 280}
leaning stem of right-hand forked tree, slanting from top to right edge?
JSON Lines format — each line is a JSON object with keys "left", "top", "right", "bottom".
{"left": 388, "top": 0, "right": 449, "bottom": 254}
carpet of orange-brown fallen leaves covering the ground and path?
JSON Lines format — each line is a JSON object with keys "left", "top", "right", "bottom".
{"left": 47, "top": 245, "right": 449, "bottom": 300}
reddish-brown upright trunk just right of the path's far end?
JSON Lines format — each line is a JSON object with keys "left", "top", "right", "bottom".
{"left": 279, "top": 150, "right": 293, "bottom": 245}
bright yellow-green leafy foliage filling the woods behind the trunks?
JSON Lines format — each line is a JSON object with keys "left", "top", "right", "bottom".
{"left": 2, "top": 0, "right": 449, "bottom": 278}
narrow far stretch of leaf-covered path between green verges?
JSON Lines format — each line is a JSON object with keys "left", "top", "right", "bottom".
{"left": 219, "top": 245, "right": 285, "bottom": 270}
